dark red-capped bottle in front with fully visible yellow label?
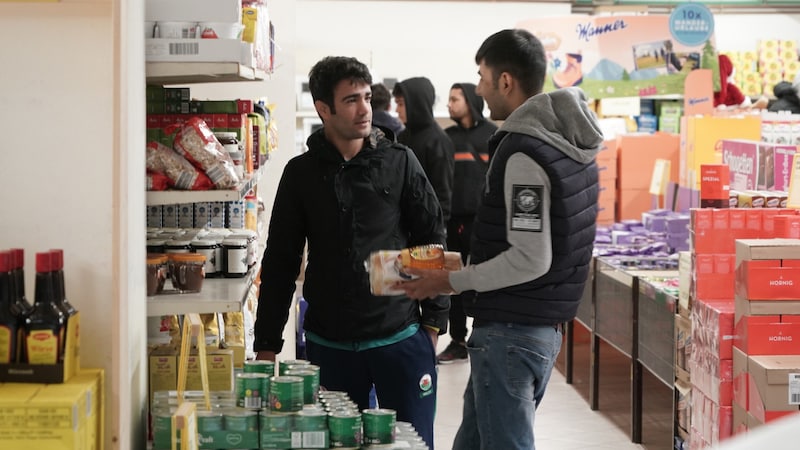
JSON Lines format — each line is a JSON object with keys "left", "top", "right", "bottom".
{"left": 23, "top": 252, "right": 64, "bottom": 364}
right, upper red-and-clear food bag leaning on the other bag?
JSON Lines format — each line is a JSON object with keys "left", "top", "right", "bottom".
{"left": 175, "top": 117, "right": 240, "bottom": 189}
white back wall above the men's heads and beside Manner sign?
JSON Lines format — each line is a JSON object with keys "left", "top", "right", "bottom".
{"left": 296, "top": 0, "right": 800, "bottom": 116}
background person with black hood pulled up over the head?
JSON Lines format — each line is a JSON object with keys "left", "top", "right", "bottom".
{"left": 392, "top": 77, "right": 454, "bottom": 223}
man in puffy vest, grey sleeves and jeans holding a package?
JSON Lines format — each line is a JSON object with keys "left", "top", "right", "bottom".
{"left": 397, "top": 29, "right": 603, "bottom": 450}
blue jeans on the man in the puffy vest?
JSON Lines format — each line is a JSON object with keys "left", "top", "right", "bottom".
{"left": 453, "top": 322, "right": 561, "bottom": 450}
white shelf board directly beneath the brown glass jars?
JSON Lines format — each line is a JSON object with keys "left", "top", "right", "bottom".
{"left": 147, "top": 264, "right": 259, "bottom": 317}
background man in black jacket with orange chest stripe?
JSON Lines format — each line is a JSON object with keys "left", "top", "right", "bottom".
{"left": 436, "top": 83, "right": 497, "bottom": 364}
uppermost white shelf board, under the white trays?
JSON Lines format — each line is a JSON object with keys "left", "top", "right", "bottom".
{"left": 145, "top": 62, "right": 267, "bottom": 85}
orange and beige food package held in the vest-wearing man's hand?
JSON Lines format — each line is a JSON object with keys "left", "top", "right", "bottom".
{"left": 364, "top": 245, "right": 463, "bottom": 295}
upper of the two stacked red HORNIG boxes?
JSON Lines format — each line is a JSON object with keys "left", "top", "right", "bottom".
{"left": 736, "top": 259, "right": 800, "bottom": 301}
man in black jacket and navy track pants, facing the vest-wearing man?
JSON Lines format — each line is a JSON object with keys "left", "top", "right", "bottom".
{"left": 253, "top": 56, "right": 450, "bottom": 449}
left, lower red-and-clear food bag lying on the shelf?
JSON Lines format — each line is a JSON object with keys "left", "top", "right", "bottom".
{"left": 145, "top": 141, "right": 214, "bottom": 191}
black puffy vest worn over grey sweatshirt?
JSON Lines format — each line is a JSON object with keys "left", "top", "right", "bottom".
{"left": 464, "top": 133, "right": 598, "bottom": 325}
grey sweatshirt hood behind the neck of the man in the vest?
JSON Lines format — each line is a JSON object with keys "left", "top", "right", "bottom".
{"left": 500, "top": 87, "right": 603, "bottom": 163}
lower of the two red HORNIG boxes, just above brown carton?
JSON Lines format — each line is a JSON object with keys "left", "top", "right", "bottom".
{"left": 733, "top": 315, "right": 800, "bottom": 355}
